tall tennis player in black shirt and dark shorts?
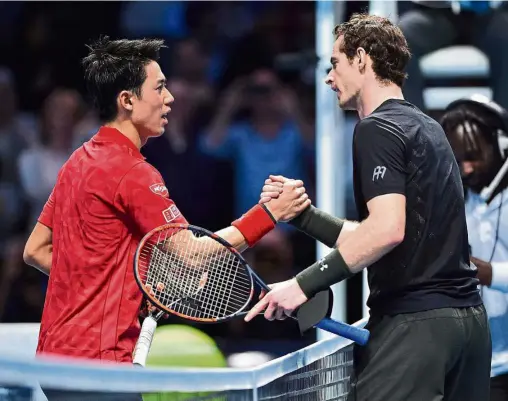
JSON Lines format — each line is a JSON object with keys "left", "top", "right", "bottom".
{"left": 246, "top": 14, "right": 491, "bottom": 401}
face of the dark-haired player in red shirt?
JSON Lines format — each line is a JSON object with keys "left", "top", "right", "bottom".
{"left": 131, "top": 61, "right": 174, "bottom": 141}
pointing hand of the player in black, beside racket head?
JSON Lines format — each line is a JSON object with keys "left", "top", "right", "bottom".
{"left": 244, "top": 278, "right": 307, "bottom": 322}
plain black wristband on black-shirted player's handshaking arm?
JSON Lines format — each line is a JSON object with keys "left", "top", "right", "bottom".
{"left": 289, "top": 205, "right": 344, "bottom": 248}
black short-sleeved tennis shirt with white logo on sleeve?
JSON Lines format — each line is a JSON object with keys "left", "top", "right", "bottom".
{"left": 353, "top": 99, "right": 482, "bottom": 315}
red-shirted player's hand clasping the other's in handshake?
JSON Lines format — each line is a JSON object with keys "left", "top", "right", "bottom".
{"left": 265, "top": 180, "right": 311, "bottom": 222}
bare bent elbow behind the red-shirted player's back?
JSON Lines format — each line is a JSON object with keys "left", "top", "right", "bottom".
{"left": 23, "top": 222, "right": 53, "bottom": 276}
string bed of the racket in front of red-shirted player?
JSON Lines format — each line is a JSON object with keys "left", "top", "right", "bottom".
{"left": 138, "top": 229, "right": 252, "bottom": 320}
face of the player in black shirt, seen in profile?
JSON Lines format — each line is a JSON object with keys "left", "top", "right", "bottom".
{"left": 325, "top": 36, "right": 364, "bottom": 110}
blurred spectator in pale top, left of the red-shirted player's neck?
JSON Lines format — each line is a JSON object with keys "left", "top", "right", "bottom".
{"left": 19, "top": 89, "right": 83, "bottom": 226}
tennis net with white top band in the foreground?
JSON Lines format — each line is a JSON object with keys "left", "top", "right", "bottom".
{"left": 0, "top": 321, "right": 365, "bottom": 401}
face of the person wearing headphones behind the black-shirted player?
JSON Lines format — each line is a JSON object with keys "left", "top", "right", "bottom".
{"left": 446, "top": 121, "right": 502, "bottom": 193}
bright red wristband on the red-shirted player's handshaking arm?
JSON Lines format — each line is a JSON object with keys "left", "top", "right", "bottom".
{"left": 231, "top": 204, "right": 277, "bottom": 247}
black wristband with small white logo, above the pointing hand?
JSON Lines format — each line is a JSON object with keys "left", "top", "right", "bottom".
{"left": 296, "top": 249, "right": 354, "bottom": 299}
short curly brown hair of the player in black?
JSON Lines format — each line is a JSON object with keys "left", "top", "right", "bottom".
{"left": 333, "top": 14, "right": 411, "bottom": 87}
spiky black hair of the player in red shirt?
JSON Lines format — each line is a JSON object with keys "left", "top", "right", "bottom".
{"left": 83, "top": 36, "right": 165, "bottom": 121}
